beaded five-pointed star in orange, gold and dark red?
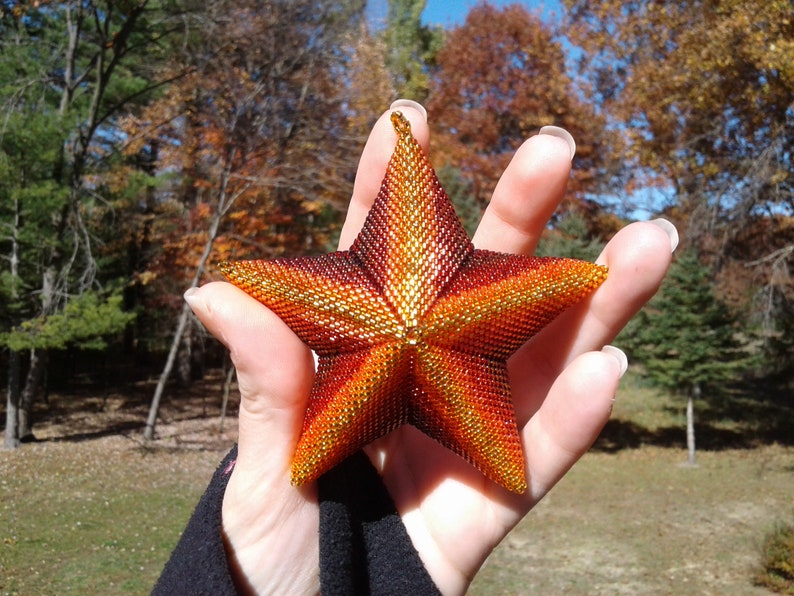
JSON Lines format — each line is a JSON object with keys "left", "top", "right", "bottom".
{"left": 220, "top": 112, "right": 606, "bottom": 493}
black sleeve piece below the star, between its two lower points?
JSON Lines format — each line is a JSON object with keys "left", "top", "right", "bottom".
{"left": 319, "top": 452, "right": 440, "bottom": 596}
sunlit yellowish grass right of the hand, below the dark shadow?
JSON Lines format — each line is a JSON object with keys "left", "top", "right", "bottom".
{"left": 471, "top": 447, "right": 794, "bottom": 596}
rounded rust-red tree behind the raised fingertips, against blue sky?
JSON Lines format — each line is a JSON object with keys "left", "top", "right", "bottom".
{"left": 428, "top": 3, "right": 619, "bottom": 210}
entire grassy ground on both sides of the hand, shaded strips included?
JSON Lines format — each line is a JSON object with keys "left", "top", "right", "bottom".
{"left": 0, "top": 370, "right": 794, "bottom": 595}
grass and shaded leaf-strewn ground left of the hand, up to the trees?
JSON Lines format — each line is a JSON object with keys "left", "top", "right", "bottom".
{"left": 0, "top": 380, "right": 236, "bottom": 596}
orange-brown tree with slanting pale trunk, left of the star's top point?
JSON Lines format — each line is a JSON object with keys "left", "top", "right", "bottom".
{"left": 126, "top": 0, "right": 363, "bottom": 439}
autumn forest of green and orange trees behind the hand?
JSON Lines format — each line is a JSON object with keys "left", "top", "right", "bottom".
{"left": 0, "top": 0, "right": 794, "bottom": 448}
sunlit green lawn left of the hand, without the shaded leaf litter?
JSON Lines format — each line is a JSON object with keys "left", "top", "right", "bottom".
{"left": 0, "top": 426, "right": 222, "bottom": 595}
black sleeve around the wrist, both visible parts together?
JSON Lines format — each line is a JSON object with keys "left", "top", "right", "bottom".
{"left": 153, "top": 447, "right": 440, "bottom": 596}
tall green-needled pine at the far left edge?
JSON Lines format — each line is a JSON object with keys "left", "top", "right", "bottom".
{"left": 0, "top": 0, "right": 183, "bottom": 447}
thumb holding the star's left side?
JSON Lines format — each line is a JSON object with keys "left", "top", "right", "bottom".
{"left": 185, "top": 282, "right": 314, "bottom": 483}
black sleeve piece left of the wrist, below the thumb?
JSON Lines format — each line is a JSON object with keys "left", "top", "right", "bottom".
{"left": 152, "top": 445, "right": 237, "bottom": 596}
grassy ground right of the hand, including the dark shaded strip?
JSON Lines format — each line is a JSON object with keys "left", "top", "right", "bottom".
{"left": 471, "top": 373, "right": 794, "bottom": 596}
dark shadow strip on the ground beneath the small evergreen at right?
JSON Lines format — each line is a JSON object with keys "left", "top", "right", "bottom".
{"left": 593, "top": 385, "right": 794, "bottom": 453}
